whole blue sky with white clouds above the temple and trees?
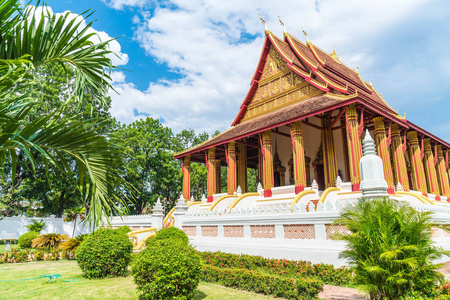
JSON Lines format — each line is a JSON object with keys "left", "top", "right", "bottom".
{"left": 42, "top": 0, "right": 450, "bottom": 141}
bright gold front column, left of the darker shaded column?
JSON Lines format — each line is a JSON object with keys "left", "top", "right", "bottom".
{"left": 291, "top": 121, "right": 306, "bottom": 194}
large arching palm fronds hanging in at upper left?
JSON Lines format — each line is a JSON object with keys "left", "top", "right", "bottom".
{"left": 0, "top": 0, "right": 131, "bottom": 225}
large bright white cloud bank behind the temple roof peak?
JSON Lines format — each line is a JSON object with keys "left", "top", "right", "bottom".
{"left": 110, "top": 0, "right": 440, "bottom": 132}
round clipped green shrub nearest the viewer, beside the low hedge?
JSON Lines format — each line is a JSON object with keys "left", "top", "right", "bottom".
{"left": 131, "top": 239, "right": 201, "bottom": 300}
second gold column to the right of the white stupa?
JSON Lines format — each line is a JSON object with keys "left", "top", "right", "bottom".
{"left": 391, "top": 124, "right": 409, "bottom": 191}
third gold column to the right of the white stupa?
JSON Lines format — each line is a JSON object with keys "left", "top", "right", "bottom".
{"left": 408, "top": 131, "right": 428, "bottom": 196}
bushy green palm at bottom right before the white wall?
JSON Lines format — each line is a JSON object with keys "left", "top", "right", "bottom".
{"left": 335, "top": 199, "right": 448, "bottom": 299}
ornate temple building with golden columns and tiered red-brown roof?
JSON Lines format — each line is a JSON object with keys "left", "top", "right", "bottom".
{"left": 175, "top": 25, "right": 450, "bottom": 210}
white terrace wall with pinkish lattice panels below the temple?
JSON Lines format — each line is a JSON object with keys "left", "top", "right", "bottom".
{"left": 181, "top": 201, "right": 450, "bottom": 267}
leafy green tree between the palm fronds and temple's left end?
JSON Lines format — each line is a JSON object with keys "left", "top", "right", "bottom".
{"left": 115, "top": 117, "right": 181, "bottom": 214}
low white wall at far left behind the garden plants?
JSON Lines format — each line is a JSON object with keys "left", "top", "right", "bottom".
{"left": 0, "top": 217, "right": 90, "bottom": 240}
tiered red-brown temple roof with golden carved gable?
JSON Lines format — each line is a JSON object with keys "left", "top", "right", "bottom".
{"left": 175, "top": 31, "right": 450, "bottom": 162}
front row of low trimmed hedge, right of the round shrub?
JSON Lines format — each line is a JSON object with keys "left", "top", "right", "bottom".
{"left": 201, "top": 265, "right": 323, "bottom": 299}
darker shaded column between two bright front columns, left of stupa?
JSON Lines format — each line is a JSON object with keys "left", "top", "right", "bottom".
{"left": 322, "top": 115, "right": 337, "bottom": 189}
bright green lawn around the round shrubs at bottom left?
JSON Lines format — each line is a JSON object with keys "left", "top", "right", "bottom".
{"left": 0, "top": 260, "right": 273, "bottom": 300}
